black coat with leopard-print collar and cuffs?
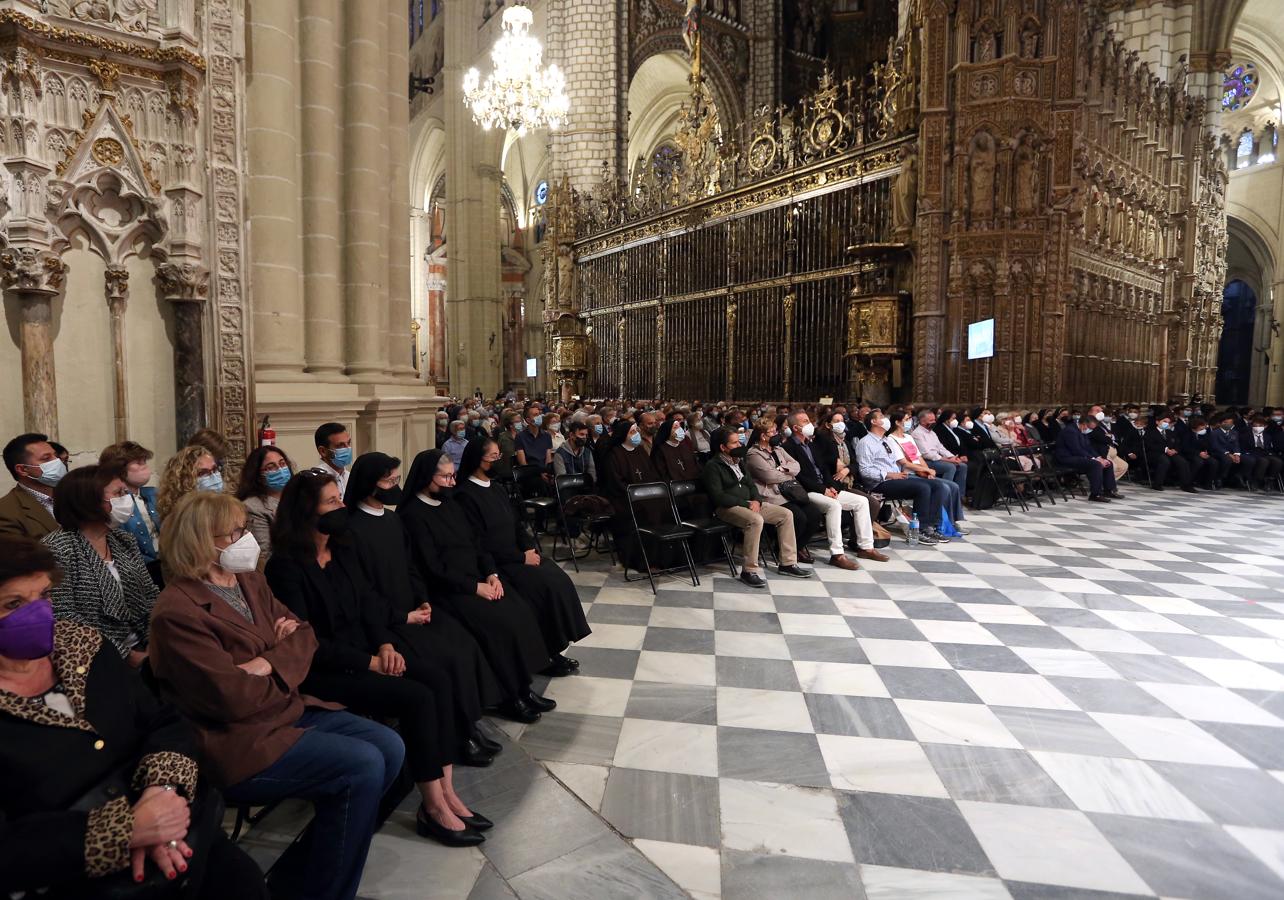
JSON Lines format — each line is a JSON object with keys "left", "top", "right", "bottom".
{"left": 0, "top": 621, "right": 196, "bottom": 896}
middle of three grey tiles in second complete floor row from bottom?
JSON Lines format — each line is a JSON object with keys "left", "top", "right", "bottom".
{"left": 923, "top": 743, "right": 1073, "bottom": 809}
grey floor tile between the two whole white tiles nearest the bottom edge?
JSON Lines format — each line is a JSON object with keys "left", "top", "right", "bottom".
{"left": 838, "top": 793, "right": 995, "bottom": 876}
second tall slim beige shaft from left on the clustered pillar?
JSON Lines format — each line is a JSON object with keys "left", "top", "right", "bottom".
{"left": 297, "top": 0, "right": 344, "bottom": 380}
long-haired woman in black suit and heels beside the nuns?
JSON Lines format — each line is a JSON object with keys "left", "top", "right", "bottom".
{"left": 263, "top": 471, "right": 490, "bottom": 847}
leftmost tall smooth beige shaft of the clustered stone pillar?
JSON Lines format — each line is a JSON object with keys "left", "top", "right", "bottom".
{"left": 251, "top": 0, "right": 309, "bottom": 380}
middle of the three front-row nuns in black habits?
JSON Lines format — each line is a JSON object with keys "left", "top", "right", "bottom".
{"left": 397, "top": 449, "right": 557, "bottom": 722}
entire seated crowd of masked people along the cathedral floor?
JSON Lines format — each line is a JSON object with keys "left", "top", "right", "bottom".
{"left": 0, "top": 397, "right": 1284, "bottom": 897}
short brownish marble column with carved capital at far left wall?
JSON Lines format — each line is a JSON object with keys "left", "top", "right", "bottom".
{"left": 0, "top": 248, "right": 67, "bottom": 438}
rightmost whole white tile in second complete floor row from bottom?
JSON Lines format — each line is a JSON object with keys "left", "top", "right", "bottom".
{"left": 1031, "top": 750, "right": 1211, "bottom": 822}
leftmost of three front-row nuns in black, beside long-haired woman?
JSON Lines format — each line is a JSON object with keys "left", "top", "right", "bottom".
{"left": 343, "top": 453, "right": 502, "bottom": 765}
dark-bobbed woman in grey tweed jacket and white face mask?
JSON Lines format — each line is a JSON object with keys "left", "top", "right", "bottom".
{"left": 44, "top": 466, "right": 159, "bottom": 669}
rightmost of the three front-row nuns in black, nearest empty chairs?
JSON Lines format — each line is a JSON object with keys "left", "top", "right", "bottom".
{"left": 456, "top": 438, "right": 592, "bottom": 677}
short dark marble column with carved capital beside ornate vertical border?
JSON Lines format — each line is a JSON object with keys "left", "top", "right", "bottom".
{"left": 157, "top": 263, "right": 209, "bottom": 444}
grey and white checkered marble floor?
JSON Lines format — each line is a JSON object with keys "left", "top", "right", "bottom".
{"left": 252, "top": 488, "right": 1284, "bottom": 900}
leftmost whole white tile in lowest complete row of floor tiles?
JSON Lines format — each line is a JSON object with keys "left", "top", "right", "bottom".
{"left": 720, "top": 778, "right": 854, "bottom": 857}
